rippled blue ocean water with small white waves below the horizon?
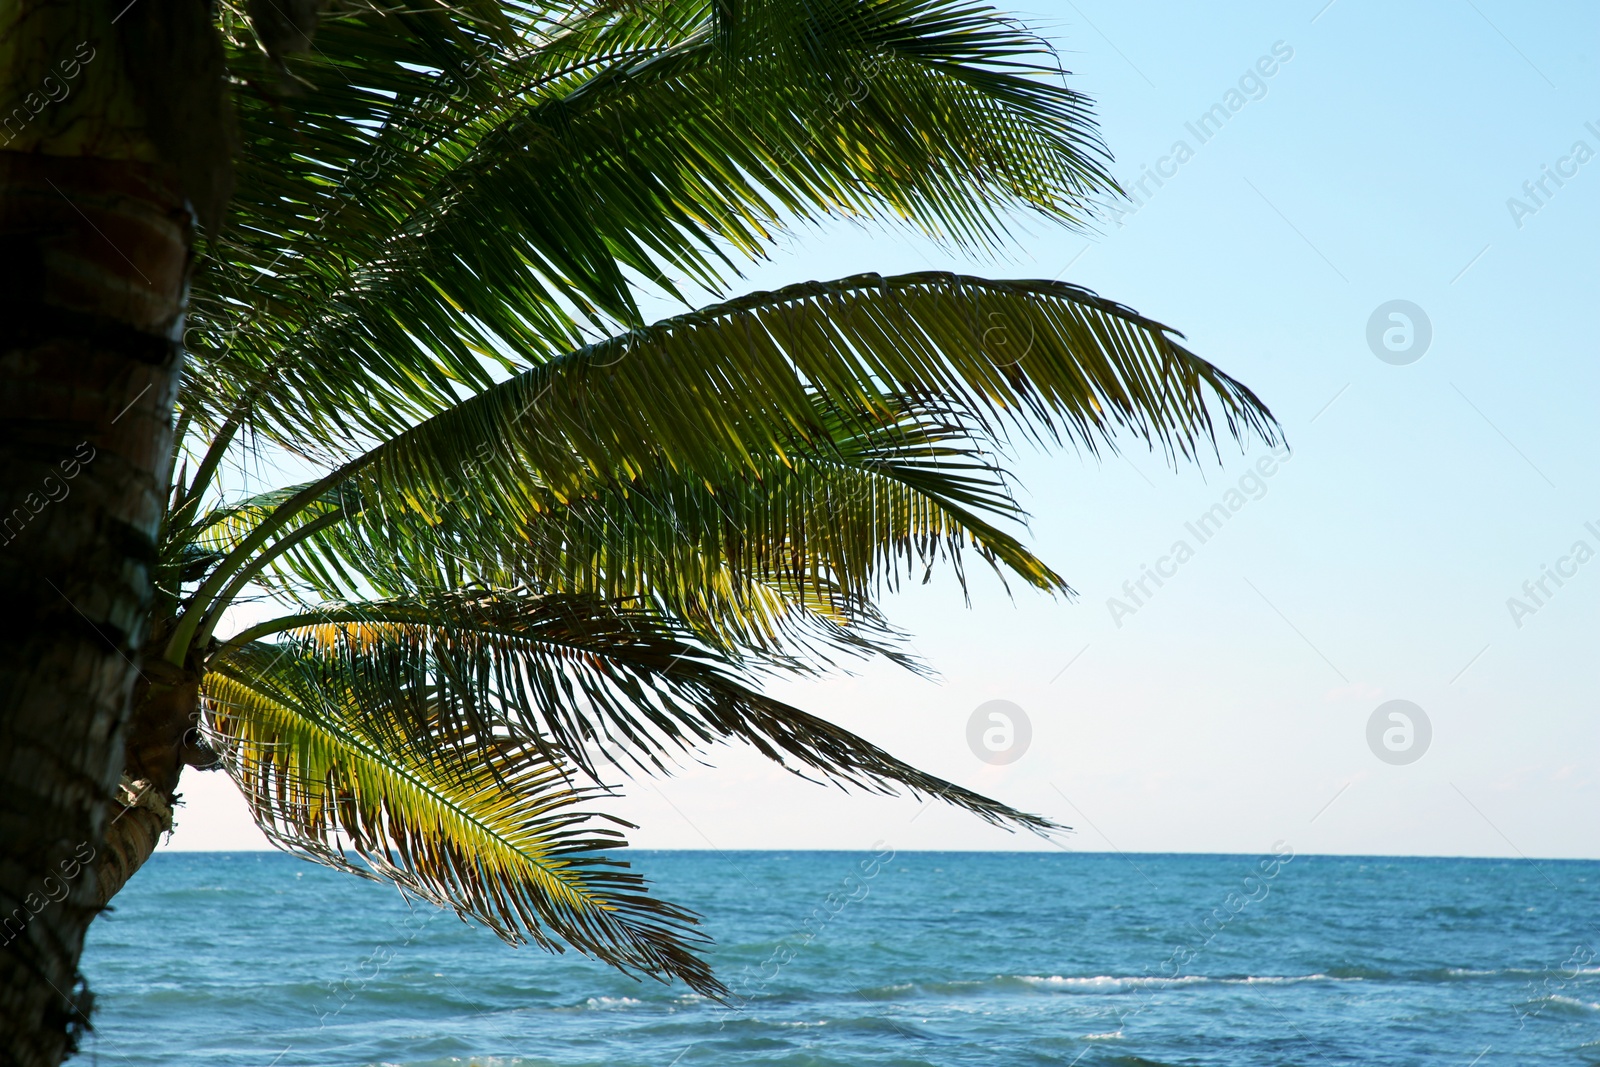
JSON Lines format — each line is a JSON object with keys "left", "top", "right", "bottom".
{"left": 78, "top": 851, "right": 1600, "bottom": 1067}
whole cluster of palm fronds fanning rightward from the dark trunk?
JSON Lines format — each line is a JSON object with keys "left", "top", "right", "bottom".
{"left": 0, "top": 0, "right": 1275, "bottom": 1049}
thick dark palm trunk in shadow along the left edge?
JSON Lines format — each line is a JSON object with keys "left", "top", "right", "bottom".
{"left": 0, "top": 0, "right": 192, "bottom": 1067}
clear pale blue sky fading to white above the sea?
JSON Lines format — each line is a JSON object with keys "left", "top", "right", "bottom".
{"left": 170, "top": 0, "right": 1600, "bottom": 857}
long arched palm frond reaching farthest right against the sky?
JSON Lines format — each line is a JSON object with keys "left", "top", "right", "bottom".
{"left": 297, "top": 274, "right": 1275, "bottom": 523}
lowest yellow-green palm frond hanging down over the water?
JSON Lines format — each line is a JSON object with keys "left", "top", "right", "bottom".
{"left": 203, "top": 645, "right": 725, "bottom": 995}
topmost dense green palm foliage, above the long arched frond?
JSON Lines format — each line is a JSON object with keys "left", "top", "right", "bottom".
{"left": 190, "top": 0, "right": 1110, "bottom": 450}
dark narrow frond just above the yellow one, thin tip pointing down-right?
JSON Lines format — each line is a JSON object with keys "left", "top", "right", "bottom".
{"left": 222, "top": 590, "right": 1053, "bottom": 832}
